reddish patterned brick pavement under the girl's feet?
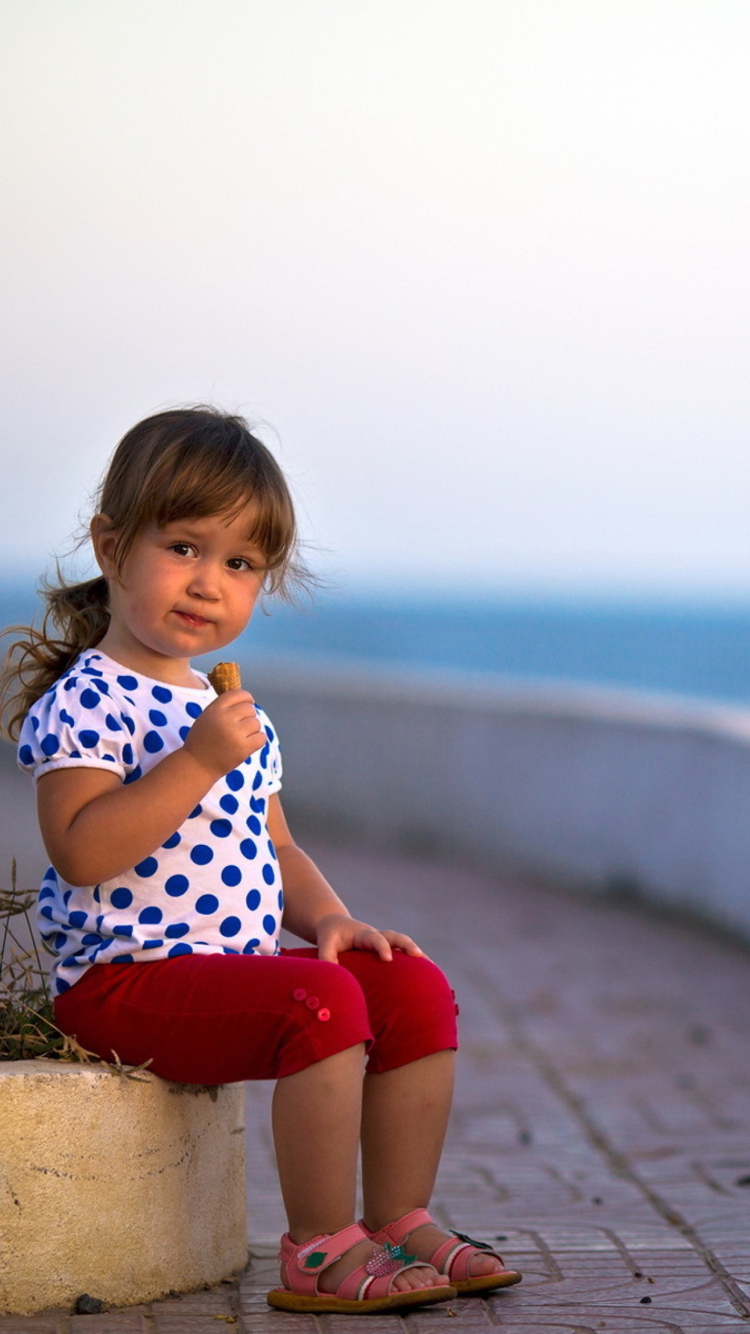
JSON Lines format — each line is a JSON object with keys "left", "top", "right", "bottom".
{"left": 0, "top": 847, "right": 750, "bottom": 1334}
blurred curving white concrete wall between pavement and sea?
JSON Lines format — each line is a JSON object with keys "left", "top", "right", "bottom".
{"left": 243, "top": 663, "right": 750, "bottom": 938}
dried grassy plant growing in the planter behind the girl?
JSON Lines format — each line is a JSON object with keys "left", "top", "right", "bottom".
{"left": 0, "top": 858, "right": 151, "bottom": 1079}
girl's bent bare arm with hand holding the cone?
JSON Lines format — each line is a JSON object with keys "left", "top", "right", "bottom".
{"left": 36, "top": 690, "right": 266, "bottom": 884}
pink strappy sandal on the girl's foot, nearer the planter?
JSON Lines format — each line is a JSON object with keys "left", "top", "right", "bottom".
{"left": 266, "top": 1223, "right": 455, "bottom": 1315}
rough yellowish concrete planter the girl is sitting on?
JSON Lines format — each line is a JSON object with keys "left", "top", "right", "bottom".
{"left": 0, "top": 1061, "right": 247, "bottom": 1315}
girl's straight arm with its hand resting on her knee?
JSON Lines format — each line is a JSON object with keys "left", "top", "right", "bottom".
{"left": 268, "top": 794, "right": 423, "bottom": 963}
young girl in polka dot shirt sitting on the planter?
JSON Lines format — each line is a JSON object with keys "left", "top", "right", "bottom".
{"left": 7, "top": 408, "right": 520, "bottom": 1313}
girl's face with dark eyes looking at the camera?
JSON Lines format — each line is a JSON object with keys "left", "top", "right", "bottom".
{"left": 92, "top": 504, "right": 264, "bottom": 686}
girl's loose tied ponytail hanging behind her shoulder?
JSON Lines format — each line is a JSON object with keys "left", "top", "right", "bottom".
{"left": 0, "top": 575, "right": 109, "bottom": 740}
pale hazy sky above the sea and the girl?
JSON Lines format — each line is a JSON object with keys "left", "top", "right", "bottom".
{"left": 0, "top": 0, "right": 750, "bottom": 596}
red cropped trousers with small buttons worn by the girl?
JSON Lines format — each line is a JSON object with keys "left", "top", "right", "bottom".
{"left": 55, "top": 948, "right": 458, "bottom": 1085}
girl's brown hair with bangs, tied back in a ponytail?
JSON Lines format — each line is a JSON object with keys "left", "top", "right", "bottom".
{"left": 0, "top": 407, "right": 306, "bottom": 738}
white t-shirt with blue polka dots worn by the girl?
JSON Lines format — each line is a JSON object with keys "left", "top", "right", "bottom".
{"left": 19, "top": 650, "right": 283, "bottom": 994}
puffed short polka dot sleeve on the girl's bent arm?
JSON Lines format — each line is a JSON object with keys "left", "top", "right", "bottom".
{"left": 19, "top": 671, "right": 136, "bottom": 782}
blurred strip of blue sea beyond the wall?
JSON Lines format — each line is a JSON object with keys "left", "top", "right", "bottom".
{"left": 0, "top": 584, "right": 750, "bottom": 704}
